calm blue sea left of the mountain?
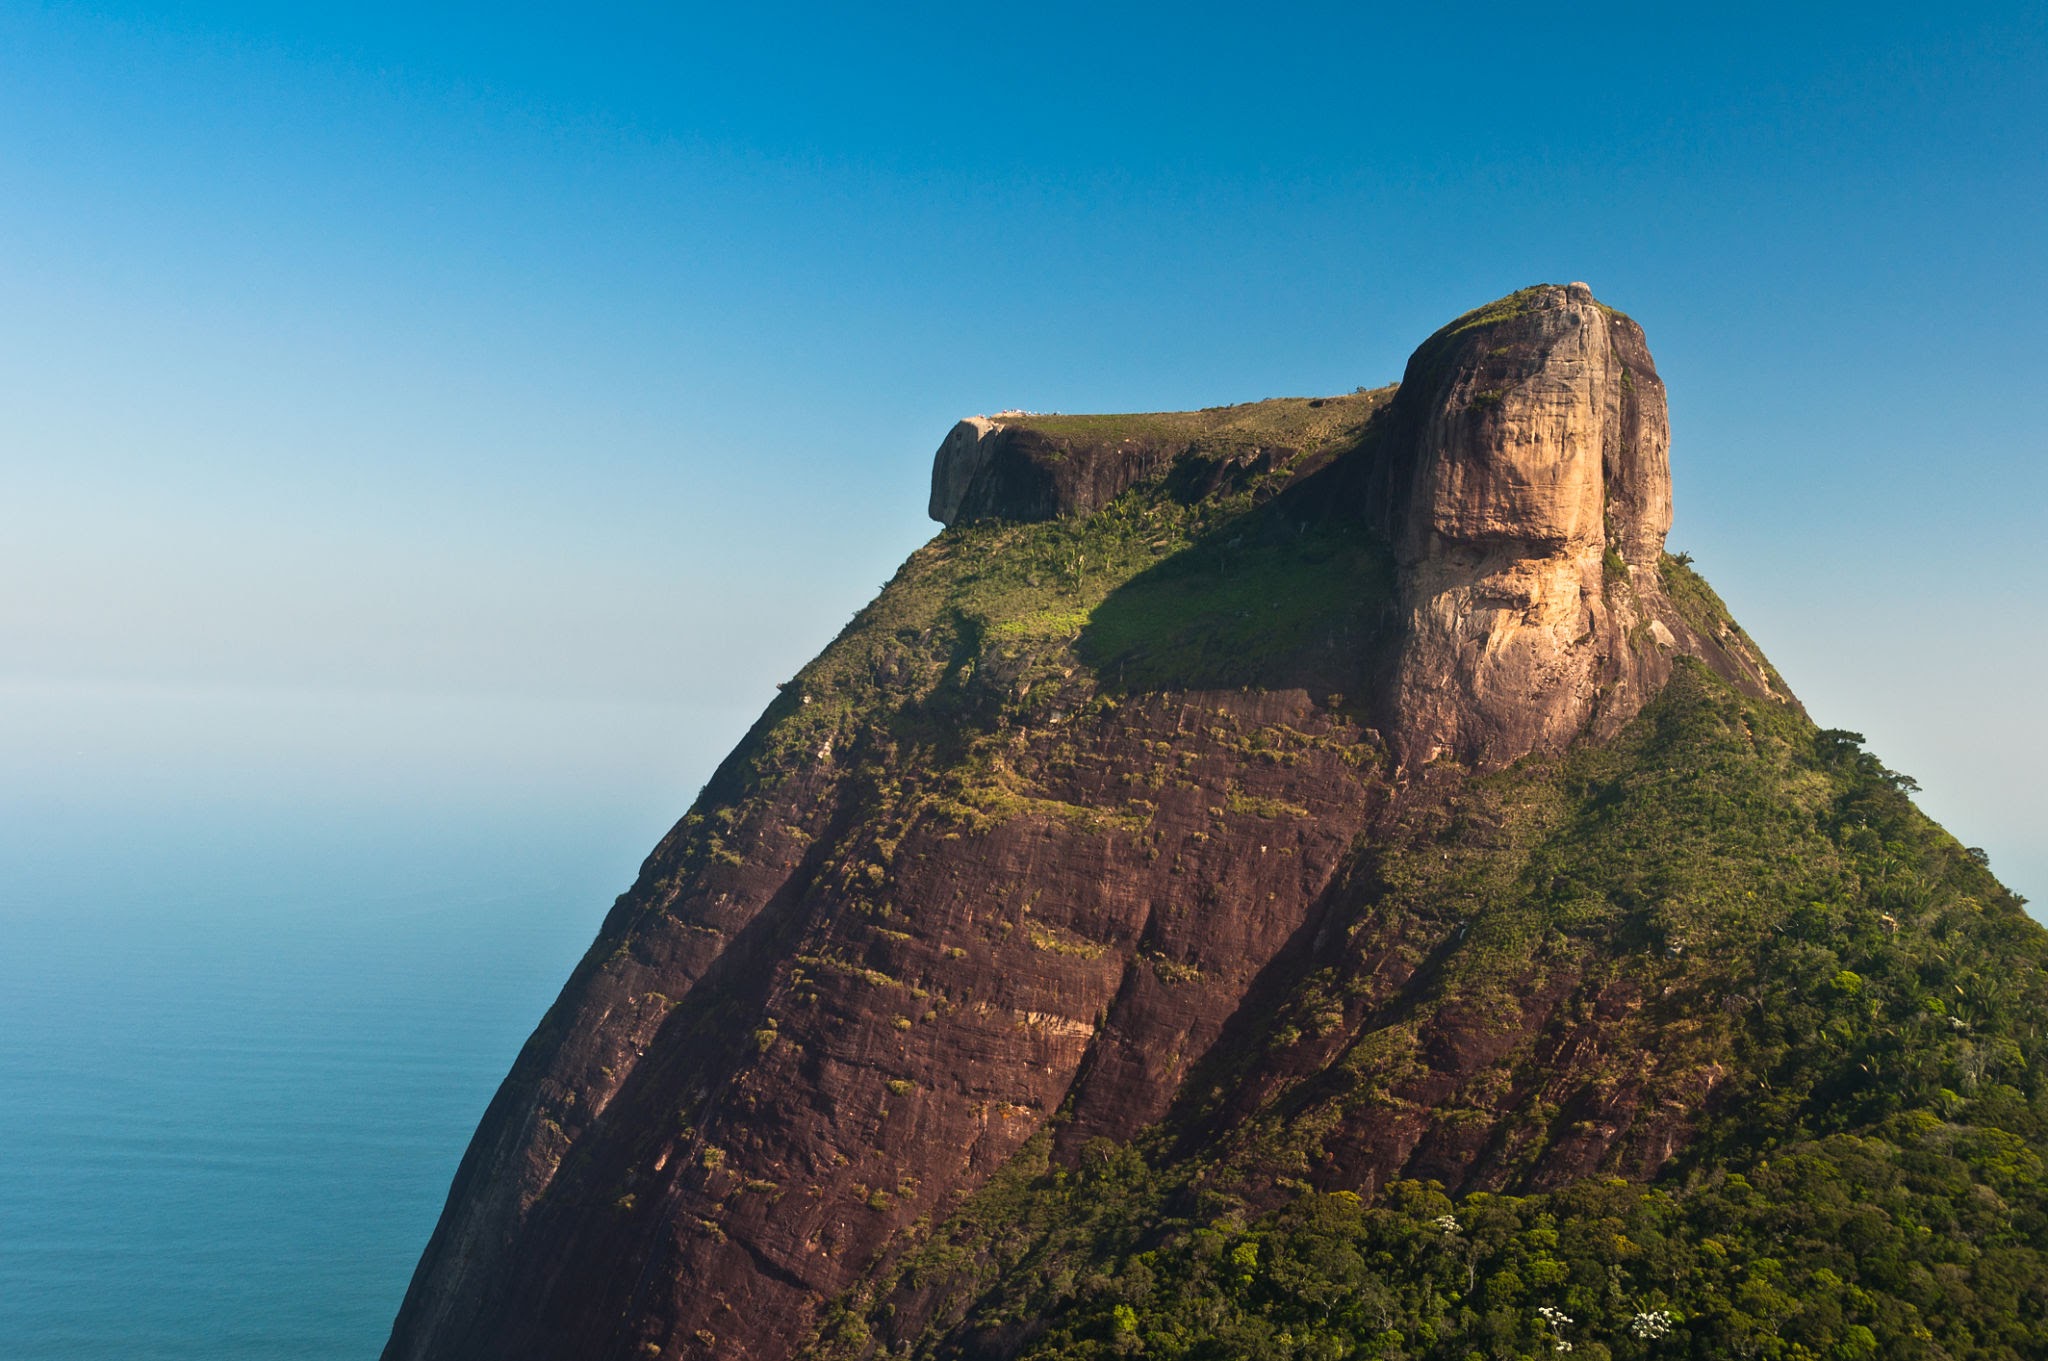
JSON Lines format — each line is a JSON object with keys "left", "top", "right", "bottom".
{"left": 0, "top": 808, "right": 651, "bottom": 1361}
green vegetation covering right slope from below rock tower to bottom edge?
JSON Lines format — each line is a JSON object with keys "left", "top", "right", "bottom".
{"left": 817, "top": 654, "right": 2048, "bottom": 1361}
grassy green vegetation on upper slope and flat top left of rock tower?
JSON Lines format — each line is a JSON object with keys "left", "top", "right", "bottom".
{"left": 638, "top": 399, "right": 1393, "bottom": 913}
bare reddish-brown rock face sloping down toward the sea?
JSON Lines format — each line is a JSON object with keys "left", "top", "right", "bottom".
{"left": 385, "top": 694, "right": 1370, "bottom": 1359}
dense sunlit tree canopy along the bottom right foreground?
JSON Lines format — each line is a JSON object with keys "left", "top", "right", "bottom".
{"left": 974, "top": 1122, "right": 2048, "bottom": 1361}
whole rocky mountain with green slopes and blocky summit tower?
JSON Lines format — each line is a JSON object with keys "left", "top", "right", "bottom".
{"left": 385, "top": 284, "right": 2048, "bottom": 1361}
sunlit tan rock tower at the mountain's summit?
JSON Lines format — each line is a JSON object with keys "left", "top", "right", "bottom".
{"left": 1372, "top": 284, "right": 1700, "bottom": 767}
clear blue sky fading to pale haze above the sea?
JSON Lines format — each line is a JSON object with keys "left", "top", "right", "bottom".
{"left": 0, "top": 0, "right": 2048, "bottom": 905}
